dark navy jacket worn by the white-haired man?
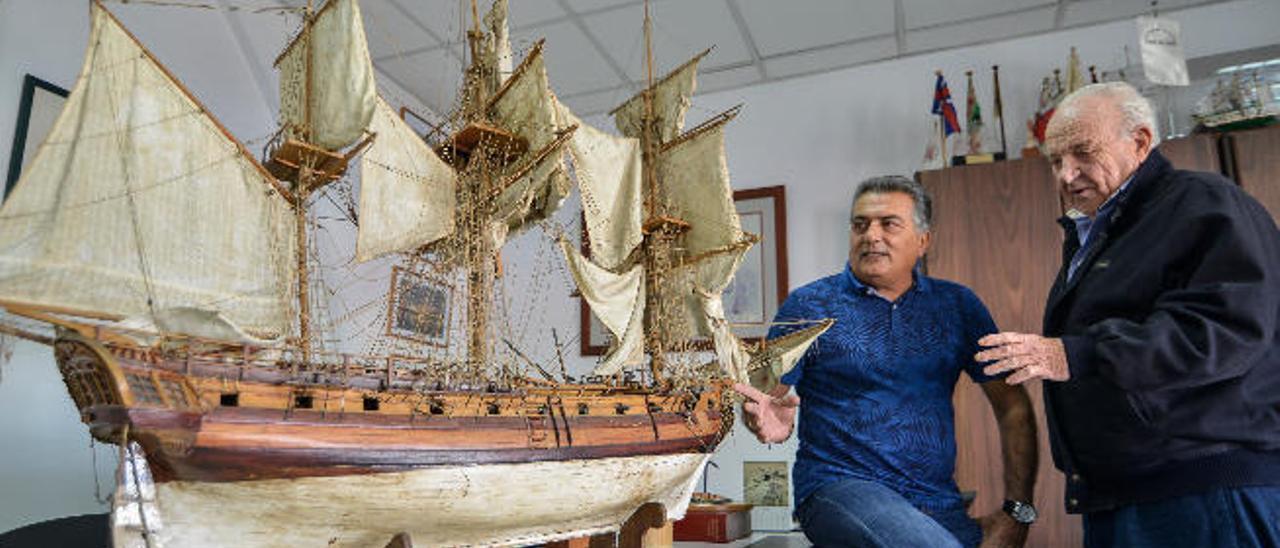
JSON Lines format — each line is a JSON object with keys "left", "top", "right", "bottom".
{"left": 1043, "top": 151, "right": 1280, "bottom": 512}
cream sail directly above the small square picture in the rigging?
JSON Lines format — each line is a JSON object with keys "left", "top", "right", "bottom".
{"left": 356, "top": 97, "right": 457, "bottom": 262}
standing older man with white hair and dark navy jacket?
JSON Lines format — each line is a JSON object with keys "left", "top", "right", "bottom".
{"left": 977, "top": 83, "right": 1280, "bottom": 547}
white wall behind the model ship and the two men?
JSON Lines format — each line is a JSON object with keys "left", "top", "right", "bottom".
{"left": 0, "top": 0, "right": 1280, "bottom": 531}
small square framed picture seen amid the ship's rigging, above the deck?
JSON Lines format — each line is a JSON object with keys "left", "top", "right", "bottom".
{"left": 387, "top": 266, "right": 453, "bottom": 348}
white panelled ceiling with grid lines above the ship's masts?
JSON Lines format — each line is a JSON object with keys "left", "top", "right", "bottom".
{"left": 282, "top": 0, "right": 1225, "bottom": 115}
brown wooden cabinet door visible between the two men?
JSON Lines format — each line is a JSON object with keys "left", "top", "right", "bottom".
{"left": 918, "top": 157, "right": 1083, "bottom": 547}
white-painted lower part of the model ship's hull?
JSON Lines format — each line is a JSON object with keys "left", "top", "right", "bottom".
{"left": 116, "top": 453, "right": 709, "bottom": 548}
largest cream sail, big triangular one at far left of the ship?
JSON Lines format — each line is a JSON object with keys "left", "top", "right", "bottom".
{"left": 0, "top": 3, "right": 294, "bottom": 335}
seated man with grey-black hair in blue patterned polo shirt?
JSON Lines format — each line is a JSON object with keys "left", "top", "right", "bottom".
{"left": 736, "top": 177, "right": 1037, "bottom": 547}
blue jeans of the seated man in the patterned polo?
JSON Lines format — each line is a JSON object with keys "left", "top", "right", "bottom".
{"left": 796, "top": 479, "right": 982, "bottom": 548}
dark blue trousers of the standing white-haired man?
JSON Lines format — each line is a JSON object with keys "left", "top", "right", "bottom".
{"left": 1084, "top": 487, "right": 1280, "bottom": 548}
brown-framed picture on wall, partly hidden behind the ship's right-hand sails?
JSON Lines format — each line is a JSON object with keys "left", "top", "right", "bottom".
{"left": 579, "top": 184, "right": 790, "bottom": 356}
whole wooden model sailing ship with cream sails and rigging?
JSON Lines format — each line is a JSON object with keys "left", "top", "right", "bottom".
{"left": 0, "top": 0, "right": 829, "bottom": 547}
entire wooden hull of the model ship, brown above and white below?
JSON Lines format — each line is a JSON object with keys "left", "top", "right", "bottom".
{"left": 54, "top": 330, "right": 732, "bottom": 547}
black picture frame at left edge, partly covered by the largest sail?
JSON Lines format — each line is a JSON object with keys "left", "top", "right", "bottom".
{"left": 4, "top": 74, "right": 68, "bottom": 197}
